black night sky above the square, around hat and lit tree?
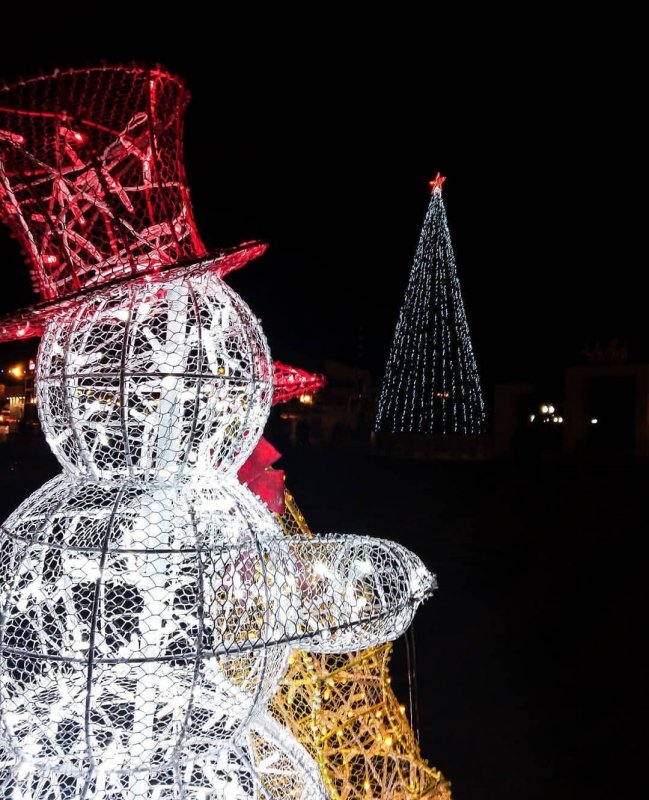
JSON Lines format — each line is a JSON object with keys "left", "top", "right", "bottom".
{"left": 0, "top": 15, "right": 649, "bottom": 396}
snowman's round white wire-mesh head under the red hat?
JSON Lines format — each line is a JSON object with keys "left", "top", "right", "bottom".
{"left": 36, "top": 270, "right": 273, "bottom": 482}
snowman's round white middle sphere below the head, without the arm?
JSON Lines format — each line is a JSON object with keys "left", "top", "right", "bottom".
{"left": 0, "top": 476, "right": 294, "bottom": 773}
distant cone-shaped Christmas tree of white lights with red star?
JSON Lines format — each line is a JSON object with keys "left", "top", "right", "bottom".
{"left": 375, "top": 173, "right": 484, "bottom": 435}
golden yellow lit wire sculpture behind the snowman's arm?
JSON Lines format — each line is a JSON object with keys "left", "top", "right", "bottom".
{"left": 272, "top": 492, "right": 451, "bottom": 800}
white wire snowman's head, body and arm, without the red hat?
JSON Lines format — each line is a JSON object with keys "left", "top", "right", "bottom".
{"left": 0, "top": 67, "right": 433, "bottom": 800}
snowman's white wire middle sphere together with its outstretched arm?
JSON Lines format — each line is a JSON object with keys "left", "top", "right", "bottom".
{"left": 0, "top": 474, "right": 431, "bottom": 796}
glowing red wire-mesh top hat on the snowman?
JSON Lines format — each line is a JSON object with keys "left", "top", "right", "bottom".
{"left": 0, "top": 67, "right": 266, "bottom": 341}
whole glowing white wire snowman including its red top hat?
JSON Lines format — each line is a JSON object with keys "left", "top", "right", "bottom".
{"left": 0, "top": 67, "right": 434, "bottom": 800}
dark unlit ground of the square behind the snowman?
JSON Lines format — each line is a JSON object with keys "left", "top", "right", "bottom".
{"left": 0, "top": 435, "right": 649, "bottom": 800}
